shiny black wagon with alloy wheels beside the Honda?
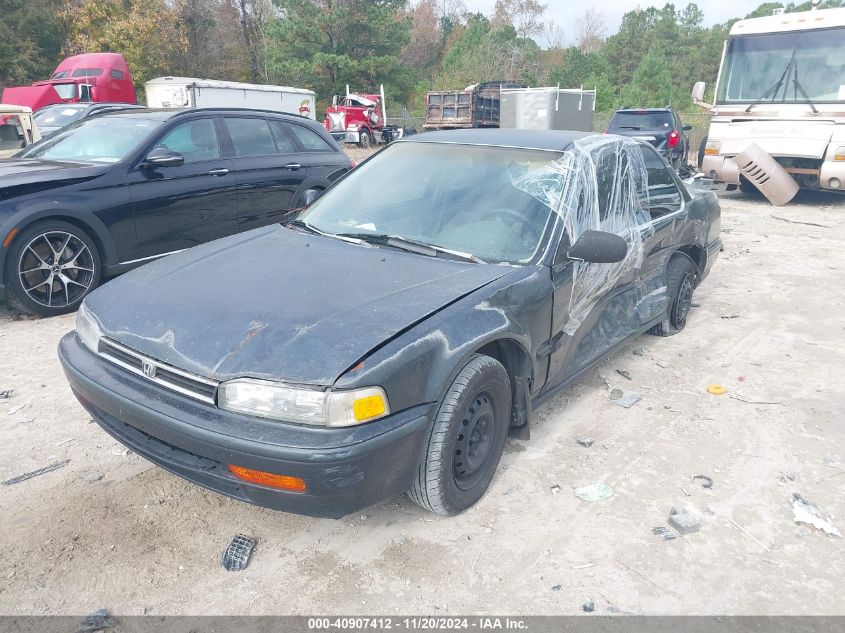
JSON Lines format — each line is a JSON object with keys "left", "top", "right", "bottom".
{"left": 0, "top": 109, "right": 352, "bottom": 316}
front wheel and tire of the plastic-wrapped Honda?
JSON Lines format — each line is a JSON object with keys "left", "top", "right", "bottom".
{"left": 408, "top": 354, "right": 511, "bottom": 516}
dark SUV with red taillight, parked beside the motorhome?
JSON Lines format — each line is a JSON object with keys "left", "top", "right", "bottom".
{"left": 607, "top": 108, "right": 692, "bottom": 169}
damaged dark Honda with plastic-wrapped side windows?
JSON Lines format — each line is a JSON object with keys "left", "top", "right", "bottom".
{"left": 59, "top": 130, "right": 720, "bottom": 517}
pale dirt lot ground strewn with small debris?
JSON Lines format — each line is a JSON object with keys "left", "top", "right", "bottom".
{"left": 0, "top": 188, "right": 845, "bottom": 614}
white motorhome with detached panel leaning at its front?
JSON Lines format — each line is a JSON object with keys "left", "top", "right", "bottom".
{"left": 693, "top": 9, "right": 845, "bottom": 199}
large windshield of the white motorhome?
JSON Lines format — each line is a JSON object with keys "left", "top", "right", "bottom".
{"left": 716, "top": 27, "right": 845, "bottom": 104}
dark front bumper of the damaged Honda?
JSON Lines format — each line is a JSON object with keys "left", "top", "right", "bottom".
{"left": 59, "top": 332, "right": 433, "bottom": 518}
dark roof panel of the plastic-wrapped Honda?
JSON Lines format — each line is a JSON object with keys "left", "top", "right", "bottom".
{"left": 403, "top": 128, "right": 595, "bottom": 151}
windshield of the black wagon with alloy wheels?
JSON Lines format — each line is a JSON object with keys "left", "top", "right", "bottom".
{"left": 19, "top": 116, "right": 162, "bottom": 163}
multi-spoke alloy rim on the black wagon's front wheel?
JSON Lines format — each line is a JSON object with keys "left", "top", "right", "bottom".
{"left": 18, "top": 231, "right": 94, "bottom": 308}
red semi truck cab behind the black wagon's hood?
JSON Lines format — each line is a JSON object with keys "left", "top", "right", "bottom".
{"left": 0, "top": 53, "right": 137, "bottom": 112}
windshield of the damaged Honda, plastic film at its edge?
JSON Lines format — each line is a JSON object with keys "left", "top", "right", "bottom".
{"left": 299, "top": 142, "right": 564, "bottom": 264}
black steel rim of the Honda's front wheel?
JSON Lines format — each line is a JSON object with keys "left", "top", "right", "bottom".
{"left": 452, "top": 391, "right": 496, "bottom": 490}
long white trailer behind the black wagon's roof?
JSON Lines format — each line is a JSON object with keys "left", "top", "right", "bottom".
{"left": 145, "top": 77, "right": 316, "bottom": 120}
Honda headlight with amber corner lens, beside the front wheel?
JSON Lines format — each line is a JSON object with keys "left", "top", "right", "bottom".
{"left": 217, "top": 378, "right": 390, "bottom": 426}
